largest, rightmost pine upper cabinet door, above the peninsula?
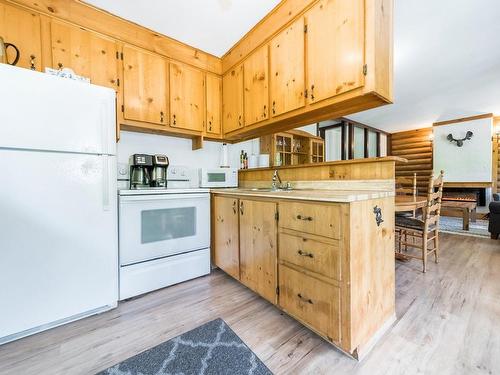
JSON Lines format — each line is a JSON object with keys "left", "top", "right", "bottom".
{"left": 306, "top": 0, "right": 364, "bottom": 103}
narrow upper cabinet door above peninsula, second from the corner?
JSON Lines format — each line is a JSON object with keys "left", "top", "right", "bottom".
{"left": 243, "top": 45, "right": 269, "bottom": 126}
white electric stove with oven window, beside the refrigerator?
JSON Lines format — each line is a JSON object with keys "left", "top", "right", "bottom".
{"left": 118, "top": 167, "right": 210, "bottom": 300}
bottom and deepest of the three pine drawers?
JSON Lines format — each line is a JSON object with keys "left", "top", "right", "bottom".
{"left": 279, "top": 265, "right": 340, "bottom": 343}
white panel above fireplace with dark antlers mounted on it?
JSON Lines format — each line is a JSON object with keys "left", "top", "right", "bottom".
{"left": 433, "top": 118, "right": 493, "bottom": 182}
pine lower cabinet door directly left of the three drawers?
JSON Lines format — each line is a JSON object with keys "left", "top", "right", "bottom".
{"left": 239, "top": 200, "right": 277, "bottom": 304}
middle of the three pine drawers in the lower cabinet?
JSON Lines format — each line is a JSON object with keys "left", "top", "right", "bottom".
{"left": 279, "top": 233, "right": 341, "bottom": 281}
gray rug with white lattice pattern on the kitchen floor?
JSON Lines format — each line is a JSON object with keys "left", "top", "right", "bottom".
{"left": 98, "top": 319, "right": 272, "bottom": 375}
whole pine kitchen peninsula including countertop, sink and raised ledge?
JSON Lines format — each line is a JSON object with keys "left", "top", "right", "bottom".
{"left": 212, "top": 157, "right": 404, "bottom": 358}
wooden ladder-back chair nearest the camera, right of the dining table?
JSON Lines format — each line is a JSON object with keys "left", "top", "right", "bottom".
{"left": 396, "top": 171, "right": 444, "bottom": 272}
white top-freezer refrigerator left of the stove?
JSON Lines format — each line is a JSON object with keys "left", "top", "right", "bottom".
{"left": 0, "top": 64, "right": 118, "bottom": 344}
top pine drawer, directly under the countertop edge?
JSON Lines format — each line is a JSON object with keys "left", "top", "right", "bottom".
{"left": 279, "top": 202, "right": 341, "bottom": 238}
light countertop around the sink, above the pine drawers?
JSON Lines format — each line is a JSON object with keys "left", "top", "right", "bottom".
{"left": 210, "top": 188, "right": 394, "bottom": 203}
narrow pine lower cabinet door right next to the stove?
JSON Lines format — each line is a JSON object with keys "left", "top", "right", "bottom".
{"left": 213, "top": 197, "right": 240, "bottom": 280}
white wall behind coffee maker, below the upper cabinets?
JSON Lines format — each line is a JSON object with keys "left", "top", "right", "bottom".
{"left": 117, "top": 131, "right": 259, "bottom": 168}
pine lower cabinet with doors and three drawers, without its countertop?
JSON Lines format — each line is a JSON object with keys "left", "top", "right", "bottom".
{"left": 213, "top": 192, "right": 395, "bottom": 359}
